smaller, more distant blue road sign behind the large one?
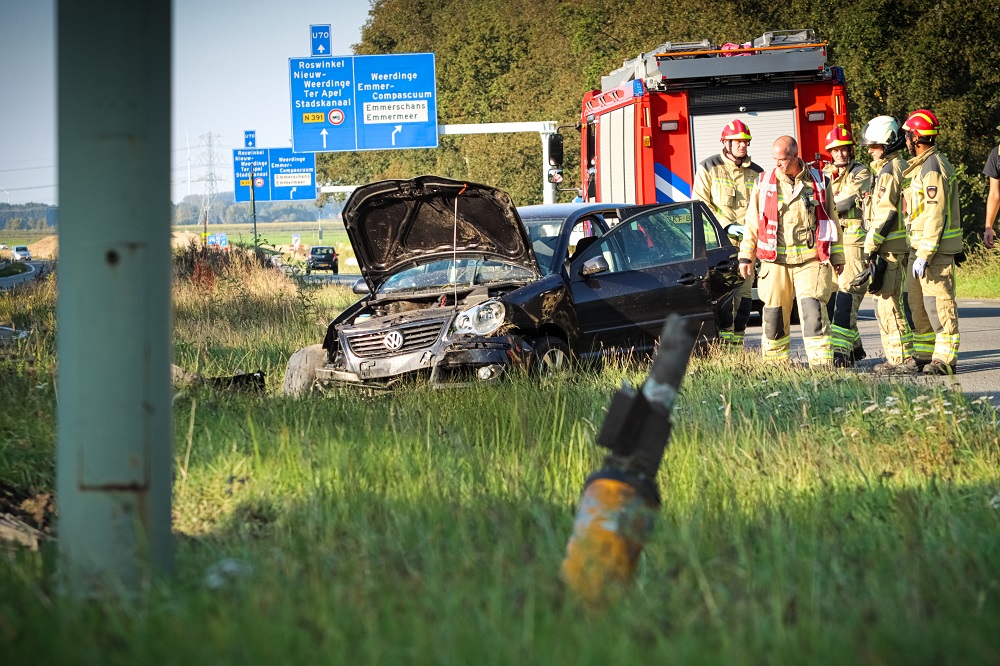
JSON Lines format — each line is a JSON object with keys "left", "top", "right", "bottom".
{"left": 233, "top": 148, "right": 316, "bottom": 202}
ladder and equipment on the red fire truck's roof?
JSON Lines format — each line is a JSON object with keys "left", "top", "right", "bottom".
{"left": 601, "top": 29, "right": 827, "bottom": 92}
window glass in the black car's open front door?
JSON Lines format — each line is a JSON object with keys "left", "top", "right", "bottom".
{"left": 616, "top": 206, "right": 694, "bottom": 270}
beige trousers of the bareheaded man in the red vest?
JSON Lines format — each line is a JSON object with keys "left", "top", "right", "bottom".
{"left": 757, "top": 259, "right": 833, "bottom": 367}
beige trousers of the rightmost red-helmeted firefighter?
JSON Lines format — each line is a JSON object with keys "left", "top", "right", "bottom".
{"left": 906, "top": 252, "right": 959, "bottom": 367}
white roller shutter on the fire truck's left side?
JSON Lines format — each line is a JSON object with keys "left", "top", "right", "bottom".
{"left": 597, "top": 104, "right": 636, "bottom": 203}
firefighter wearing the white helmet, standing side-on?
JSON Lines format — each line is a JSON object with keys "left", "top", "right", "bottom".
{"left": 860, "top": 116, "right": 919, "bottom": 375}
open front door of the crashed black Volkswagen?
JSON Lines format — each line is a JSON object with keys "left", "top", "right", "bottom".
{"left": 570, "top": 202, "right": 715, "bottom": 354}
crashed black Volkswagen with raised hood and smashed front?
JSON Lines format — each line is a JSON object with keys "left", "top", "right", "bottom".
{"left": 286, "top": 176, "right": 738, "bottom": 388}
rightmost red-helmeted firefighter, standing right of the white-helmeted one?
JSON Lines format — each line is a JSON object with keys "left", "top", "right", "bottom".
{"left": 903, "top": 109, "right": 962, "bottom": 375}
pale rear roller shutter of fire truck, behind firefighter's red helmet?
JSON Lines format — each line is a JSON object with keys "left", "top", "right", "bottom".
{"left": 691, "top": 109, "right": 799, "bottom": 173}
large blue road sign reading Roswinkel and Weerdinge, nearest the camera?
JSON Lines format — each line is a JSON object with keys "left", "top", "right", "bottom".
{"left": 288, "top": 53, "right": 438, "bottom": 153}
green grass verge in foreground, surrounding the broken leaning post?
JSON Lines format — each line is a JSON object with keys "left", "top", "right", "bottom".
{"left": 0, "top": 246, "right": 1000, "bottom": 664}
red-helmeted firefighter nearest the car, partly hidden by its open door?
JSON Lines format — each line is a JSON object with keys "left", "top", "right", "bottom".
{"left": 694, "top": 120, "right": 764, "bottom": 346}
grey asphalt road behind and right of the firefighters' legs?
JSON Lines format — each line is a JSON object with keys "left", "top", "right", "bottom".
{"left": 746, "top": 298, "right": 1000, "bottom": 405}
